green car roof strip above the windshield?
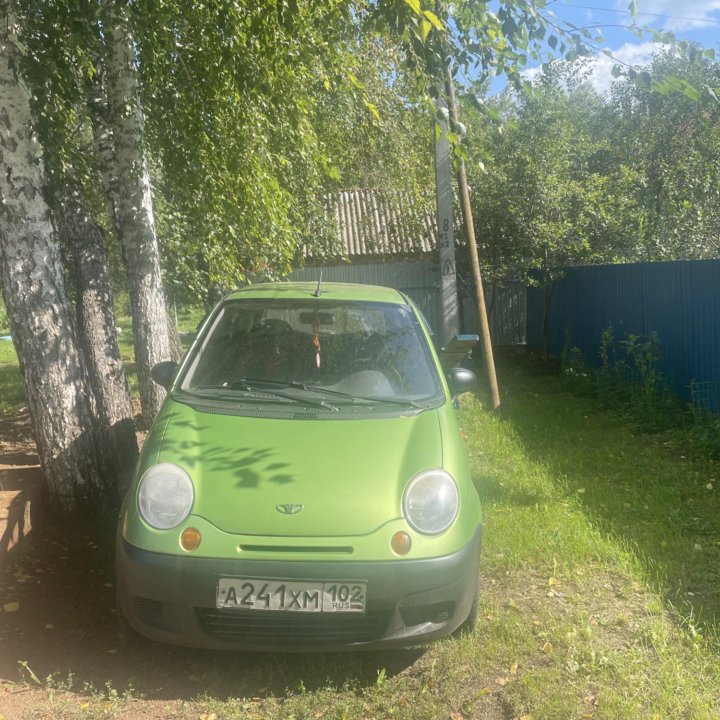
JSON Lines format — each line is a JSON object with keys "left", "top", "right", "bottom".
{"left": 226, "top": 282, "right": 407, "bottom": 305}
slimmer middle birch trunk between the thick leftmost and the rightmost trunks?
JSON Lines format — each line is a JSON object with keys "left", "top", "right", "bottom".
{"left": 56, "top": 186, "right": 138, "bottom": 493}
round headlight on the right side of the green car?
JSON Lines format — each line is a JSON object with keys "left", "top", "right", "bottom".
{"left": 403, "top": 470, "right": 460, "bottom": 535}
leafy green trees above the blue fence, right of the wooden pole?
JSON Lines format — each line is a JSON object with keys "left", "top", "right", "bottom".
{"left": 462, "top": 49, "right": 720, "bottom": 292}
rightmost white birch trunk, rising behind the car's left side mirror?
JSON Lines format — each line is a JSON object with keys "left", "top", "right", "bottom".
{"left": 106, "top": 0, "right": 171, "bottom": 423}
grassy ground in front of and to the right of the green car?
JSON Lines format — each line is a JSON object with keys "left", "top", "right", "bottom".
{"left": 1, "top": 348, "right": 720, "bottom": 720}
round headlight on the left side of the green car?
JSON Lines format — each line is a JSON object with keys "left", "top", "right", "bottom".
{"left": 138, "top": 463, "right": 195, "bottom": 530}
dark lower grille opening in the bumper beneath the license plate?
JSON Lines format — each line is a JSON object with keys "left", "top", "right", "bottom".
{"left": 195, "top": 608, "right": 391, "bottom": 646}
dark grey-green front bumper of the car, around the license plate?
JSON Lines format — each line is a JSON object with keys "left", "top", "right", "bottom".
{"left": 116, "top": 526, "right": 482, "bottom": 652}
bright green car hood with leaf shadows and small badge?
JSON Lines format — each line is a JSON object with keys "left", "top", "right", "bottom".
{"left": 148, "top": 401, "right": 443, "bottom": 537}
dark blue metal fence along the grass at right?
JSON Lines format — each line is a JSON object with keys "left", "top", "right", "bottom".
{"left": 528, "top": 260, "right": 720, "bottom": 409}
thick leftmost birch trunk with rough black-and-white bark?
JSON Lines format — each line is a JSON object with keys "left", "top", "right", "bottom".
{"left": 0, "top": 11, "right": 111, "bottom": 516}
